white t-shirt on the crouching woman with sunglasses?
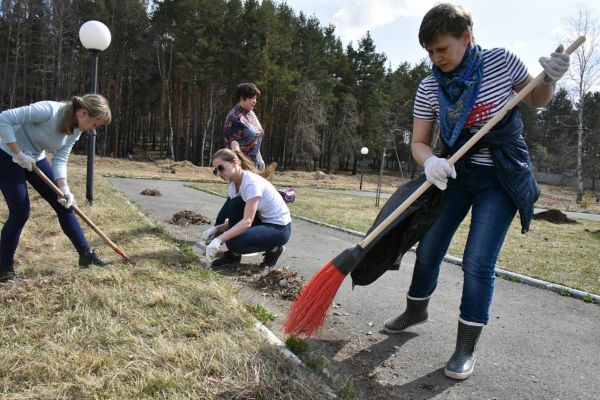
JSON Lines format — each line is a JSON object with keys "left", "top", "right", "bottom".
{"left": 229, "top": 171, "right": 292, "bottom": 225}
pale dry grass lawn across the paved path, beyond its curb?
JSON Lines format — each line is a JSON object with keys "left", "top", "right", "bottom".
{"left": 192, "top": 183, "right": 600, "bottom": 294}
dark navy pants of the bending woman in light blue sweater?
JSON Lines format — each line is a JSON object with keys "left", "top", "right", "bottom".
{"left": 0, "top": 150, "right": 90, "bottom": 269}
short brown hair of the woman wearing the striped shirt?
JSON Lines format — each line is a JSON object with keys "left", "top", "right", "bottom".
{"left": 419, "top": 3, "right": 473, "bottom": 48}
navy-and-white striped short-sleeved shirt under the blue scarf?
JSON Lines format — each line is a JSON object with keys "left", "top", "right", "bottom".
{"left": 413, "top": 49, "right": 529, "bottom": 165}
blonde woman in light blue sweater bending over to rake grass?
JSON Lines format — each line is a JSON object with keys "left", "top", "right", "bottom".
{"left": 0, "top": 94, "right": 111, "bottom": 282}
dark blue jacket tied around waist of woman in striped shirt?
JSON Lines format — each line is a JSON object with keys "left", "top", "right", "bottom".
{"left": 443, "top": 107, "right": 540, "bottom": 233}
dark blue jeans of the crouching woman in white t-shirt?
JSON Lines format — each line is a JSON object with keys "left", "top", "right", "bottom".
{"left": 215, "top": 196, "right": 292, "bottom": 254}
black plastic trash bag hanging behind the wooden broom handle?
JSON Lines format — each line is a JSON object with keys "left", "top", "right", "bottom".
{"left": 350, "top": 175, "right": 444, "bottom": 286}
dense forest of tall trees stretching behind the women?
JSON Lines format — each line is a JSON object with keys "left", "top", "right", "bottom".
{"left": 0, "top": 0, "right": 600, "bottom": 199}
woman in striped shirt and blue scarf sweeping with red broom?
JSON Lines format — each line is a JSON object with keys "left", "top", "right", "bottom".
{"left": 384, "top": 3, "right": 569, "bottom": 379}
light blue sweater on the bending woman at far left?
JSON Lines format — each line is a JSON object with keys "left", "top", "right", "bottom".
{"left": 0, "top": 101, "right": 81, "bottom": 179}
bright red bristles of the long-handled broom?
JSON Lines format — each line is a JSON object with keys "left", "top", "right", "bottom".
{"left": 283, "top": 261, "right": 346, "bottom": 337}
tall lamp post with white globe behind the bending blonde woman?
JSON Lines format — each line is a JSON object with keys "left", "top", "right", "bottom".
{"left": 79, "top": 21, "right": 111, "bottom": 203}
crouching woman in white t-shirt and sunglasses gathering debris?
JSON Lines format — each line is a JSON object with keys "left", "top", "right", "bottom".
{"left": 202, "top": 149, "right": 292, "bottom": 267}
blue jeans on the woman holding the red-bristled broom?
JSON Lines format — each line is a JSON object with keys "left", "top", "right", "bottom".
{"left": 408, "top": 162, "right": 517, "bottom": 324}
